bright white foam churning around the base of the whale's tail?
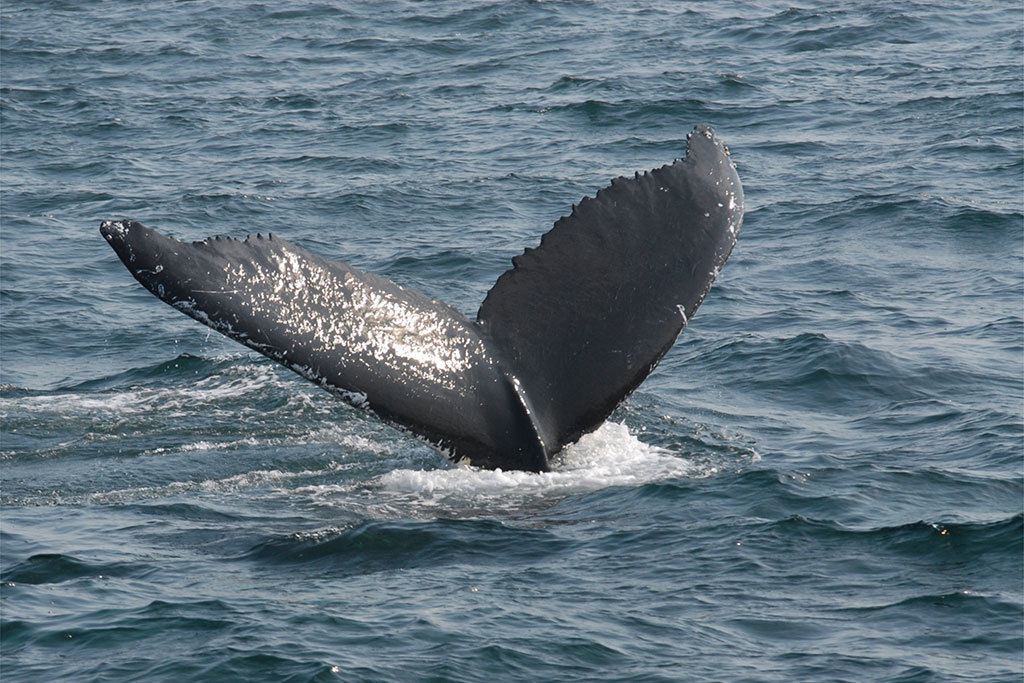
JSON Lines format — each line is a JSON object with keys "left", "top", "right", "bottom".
{"left": 379, "top": 422, "right": 717, "bottom": 502}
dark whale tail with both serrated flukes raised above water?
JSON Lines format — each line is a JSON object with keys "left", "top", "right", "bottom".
{"left": 99, "top": 125, "right": 743, "bottom": 472}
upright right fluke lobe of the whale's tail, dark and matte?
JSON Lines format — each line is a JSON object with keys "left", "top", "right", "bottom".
{"left": 477, "top": 126, "right": 743, "bottom": 454}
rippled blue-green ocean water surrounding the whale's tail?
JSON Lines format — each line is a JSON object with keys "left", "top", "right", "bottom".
{"left": 0, "top": 0, "right": 1024, "bottom": 683}
